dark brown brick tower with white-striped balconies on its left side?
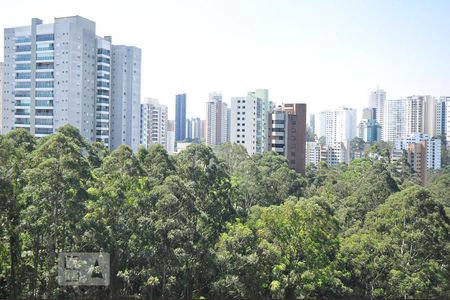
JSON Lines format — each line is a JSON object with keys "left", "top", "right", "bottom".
{"left": 268, "top": 103, "right": 306, "bottom": 173}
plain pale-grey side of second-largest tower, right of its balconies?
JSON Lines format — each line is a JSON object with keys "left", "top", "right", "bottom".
{"left": 111, "top": 45, "right": 141, "bottom": 151}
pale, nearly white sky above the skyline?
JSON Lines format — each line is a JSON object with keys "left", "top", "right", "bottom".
{"left": 0, "top": 0, "right": 450, "bottom": 118}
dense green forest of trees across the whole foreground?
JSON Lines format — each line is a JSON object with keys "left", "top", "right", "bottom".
{"left": 0, "top": 126, "right": 450, "bottom": 298}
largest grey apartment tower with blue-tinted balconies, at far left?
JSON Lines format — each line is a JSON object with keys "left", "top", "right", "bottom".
{"left": 2, "top": 16, "right": 97, "bottom": 141}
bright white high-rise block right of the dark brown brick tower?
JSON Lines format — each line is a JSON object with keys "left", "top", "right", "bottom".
{"left": 315, "top": 107, "right": 357, "bottom": 146}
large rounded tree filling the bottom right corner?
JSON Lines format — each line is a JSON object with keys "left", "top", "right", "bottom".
{"left": 338, "top": 186, "right": 450, "bottom": 298}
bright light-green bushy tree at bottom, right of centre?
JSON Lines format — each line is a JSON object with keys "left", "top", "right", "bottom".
{"left": 214, "top": 198, "right": 344, "bottom": 298}
